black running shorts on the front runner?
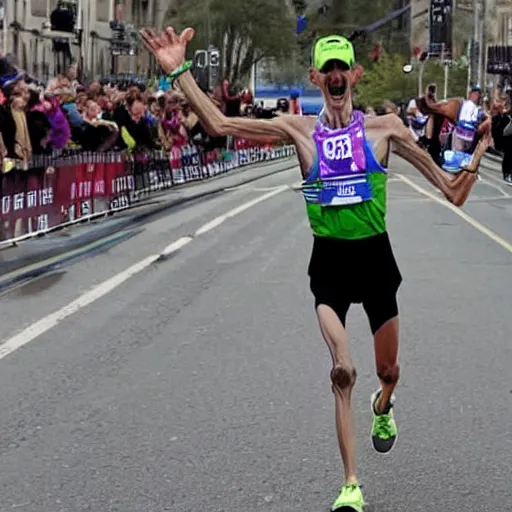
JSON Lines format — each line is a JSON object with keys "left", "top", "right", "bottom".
{"left": 308, "top": 233, "right": 402, "bottom": 334}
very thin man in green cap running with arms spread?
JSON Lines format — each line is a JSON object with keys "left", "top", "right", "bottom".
{"left": 141, "top": 27, "right": 488, "bottom": 512}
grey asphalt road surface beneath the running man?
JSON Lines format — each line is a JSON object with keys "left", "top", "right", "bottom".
{"left": 0, "top": 161, "right": 512, "bottom": 512}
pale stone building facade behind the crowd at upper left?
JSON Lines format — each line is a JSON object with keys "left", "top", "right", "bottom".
{"left": 0, "top": 0, "right": 167, "bottom": 80}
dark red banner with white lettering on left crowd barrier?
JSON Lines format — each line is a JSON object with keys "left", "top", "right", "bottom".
{"left": 0, "top": 141, "right": 295, "bottom": 241}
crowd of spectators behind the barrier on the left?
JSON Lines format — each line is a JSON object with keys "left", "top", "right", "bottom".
{"left": 0, "top": 58, "right": 276, "bottom": 172}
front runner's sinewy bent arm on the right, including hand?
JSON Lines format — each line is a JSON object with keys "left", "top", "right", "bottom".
{"left": 390, "top": 118, "right": 489, "bottom": 206}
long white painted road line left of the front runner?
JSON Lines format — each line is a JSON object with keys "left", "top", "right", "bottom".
{"left": 0, "top": 185, "right": 288, "bottom": 359}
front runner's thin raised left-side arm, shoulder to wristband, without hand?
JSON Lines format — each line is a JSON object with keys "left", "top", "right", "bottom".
{"left": 177, "top": 71, "right": 291, "bottom": 144}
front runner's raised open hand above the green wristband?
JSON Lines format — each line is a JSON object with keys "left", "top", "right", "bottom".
{"left": 140, "top": 27, "right": 194, "bottom": 73}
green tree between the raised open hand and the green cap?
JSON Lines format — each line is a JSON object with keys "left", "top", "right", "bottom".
{"left": 166, "top": 0, "right": 297, "bottom": 83}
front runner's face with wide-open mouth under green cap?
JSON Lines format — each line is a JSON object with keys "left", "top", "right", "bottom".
{"left": 310, "top": 60, "right": 351, "bottom": 110}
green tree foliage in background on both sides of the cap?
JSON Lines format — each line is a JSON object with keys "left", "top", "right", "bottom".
{"left": 165, "top": 0, "right": 467, "bottom": 106}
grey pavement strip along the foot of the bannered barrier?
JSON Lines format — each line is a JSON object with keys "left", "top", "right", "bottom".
{"left": 0, "top": 156, "right": 297, "bottom": 289}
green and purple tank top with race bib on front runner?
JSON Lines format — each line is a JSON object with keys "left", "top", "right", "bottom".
{"left": 302, "top": 111, "right": 387, "bottom": 240}
